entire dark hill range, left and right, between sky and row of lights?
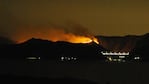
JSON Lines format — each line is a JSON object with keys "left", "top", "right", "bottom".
{"left": 0, "top": 33, "right": 149, "bottom": 61}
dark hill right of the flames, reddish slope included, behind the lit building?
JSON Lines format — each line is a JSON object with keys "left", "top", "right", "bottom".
{"left": 97, "top": 33, "right": 149, "bottom": 62}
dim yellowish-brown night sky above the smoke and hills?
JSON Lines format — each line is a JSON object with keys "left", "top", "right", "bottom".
{"left": 0, "top": 0, "right": 149, "bottom": 36}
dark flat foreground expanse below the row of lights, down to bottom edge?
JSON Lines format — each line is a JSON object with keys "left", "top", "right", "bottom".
{"left": 0, "top": 60, "right": 149, "bottom": 84}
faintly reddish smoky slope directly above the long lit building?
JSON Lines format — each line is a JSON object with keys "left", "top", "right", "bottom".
{"left": 97, "top": 35, "right": 141, "bottom": 52}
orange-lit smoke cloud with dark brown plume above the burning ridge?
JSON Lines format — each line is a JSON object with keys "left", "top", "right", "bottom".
{"left": 10, "top": 24, "right": 94, "bottom": 43}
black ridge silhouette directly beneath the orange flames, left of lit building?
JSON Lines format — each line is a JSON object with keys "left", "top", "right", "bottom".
{"left": 0, "top": 38, "right": 105, "bottom": 60}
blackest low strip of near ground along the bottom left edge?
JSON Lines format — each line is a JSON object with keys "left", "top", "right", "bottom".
{"left": 0, "top": 75, "right": 96, "bottom": 84}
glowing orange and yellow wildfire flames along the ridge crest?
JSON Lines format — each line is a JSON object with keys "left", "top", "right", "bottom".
{"left": 13, "top": 28, "right": 99, "bottom": 44}
